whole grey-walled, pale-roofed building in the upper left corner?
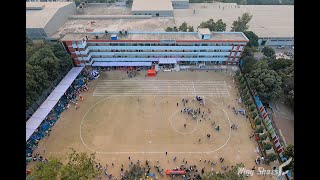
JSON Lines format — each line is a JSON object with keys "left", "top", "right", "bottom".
{"left": 26, "top": 2, "right": 76, "bottom": 39}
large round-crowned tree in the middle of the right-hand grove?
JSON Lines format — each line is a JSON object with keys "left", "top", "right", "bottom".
{"left": 246, "top": 60, "right": 281, "bottom": 103}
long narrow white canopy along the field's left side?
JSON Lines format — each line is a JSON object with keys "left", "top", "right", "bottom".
{"left": 26, "top": 67, "right": 83, "bottom": 141}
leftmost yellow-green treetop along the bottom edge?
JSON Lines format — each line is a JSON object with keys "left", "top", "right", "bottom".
{"left": 30, "top": 158, "right": 63, "bottom": 180}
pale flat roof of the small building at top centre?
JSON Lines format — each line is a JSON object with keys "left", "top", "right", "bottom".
{"left": 131, "top": 0, "right": 173, "bottom": 11}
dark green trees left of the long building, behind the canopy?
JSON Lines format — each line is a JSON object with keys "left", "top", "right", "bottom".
{"left": 26, "top": 38, "right": 73, "bottom": 109}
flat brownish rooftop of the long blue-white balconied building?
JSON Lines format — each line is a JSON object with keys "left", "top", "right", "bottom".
{"left": 61, "top": 31, "right": 248, "bottom": 42}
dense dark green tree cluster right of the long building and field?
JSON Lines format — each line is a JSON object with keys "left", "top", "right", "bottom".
{"left": 241, "top": 36, "right": 294, "bottom": 107}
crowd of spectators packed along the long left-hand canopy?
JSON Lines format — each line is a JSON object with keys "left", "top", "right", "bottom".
{"left": 26, "top": 69, "right": 94, "bottom": 164}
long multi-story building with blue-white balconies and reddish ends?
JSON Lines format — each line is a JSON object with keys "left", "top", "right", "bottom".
{"left": 60, "top": 28, "right": 249, "bottom": 67}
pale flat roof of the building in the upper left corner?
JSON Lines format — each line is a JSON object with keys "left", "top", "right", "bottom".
{"left": 26, "top": 2, "right": 73, "bottom": 28}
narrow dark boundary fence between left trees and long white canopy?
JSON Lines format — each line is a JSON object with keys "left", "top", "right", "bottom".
{"left": 26, "top": 67, "right": 72, "bottom": 122}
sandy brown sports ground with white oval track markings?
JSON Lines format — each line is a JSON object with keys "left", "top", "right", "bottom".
{"left": 28, "top": 71, "right": 271, "bottom": 179}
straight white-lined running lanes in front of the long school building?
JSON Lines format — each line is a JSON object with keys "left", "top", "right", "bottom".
{"left": 93, "top": 80, "right": 229, "bottom": 96}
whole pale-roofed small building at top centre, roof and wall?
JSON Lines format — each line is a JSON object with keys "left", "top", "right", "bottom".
{"left": 131, "top": 0, "right": 173, "bottom": 17}
